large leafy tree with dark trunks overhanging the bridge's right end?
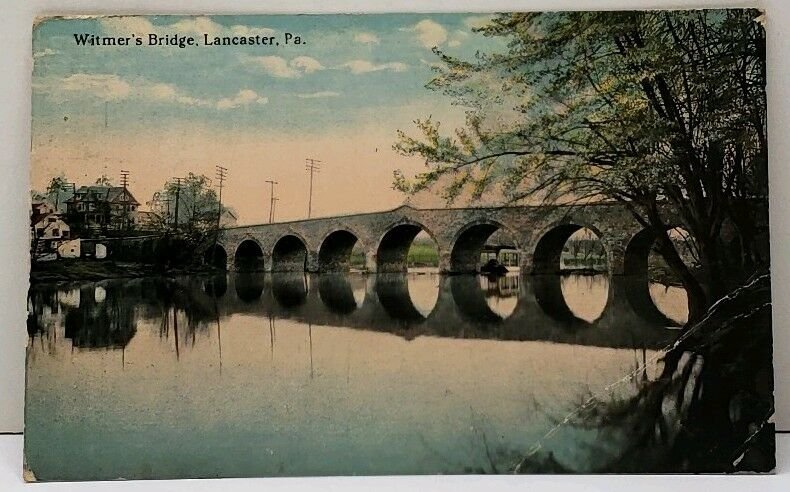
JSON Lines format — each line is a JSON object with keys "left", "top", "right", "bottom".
{"left": 394, "top": 10, "right": 768, "bottom": 320}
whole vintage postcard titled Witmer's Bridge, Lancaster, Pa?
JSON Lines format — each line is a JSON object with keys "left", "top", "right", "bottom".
{"left": 24, "top": 9, "right": 775, "bottom": 481}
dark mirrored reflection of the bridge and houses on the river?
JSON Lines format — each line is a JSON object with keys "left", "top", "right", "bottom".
{"left": 28, "top": 272, "right": 683, "bottom": 349}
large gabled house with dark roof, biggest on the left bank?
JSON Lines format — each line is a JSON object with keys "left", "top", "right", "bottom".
{"left": 66, "top": 185, "right": 140, "bottom": 234}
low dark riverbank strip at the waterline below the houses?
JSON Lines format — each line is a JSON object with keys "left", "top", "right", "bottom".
{"left": 30, "top": 259, "right": 221, "bottom": 284}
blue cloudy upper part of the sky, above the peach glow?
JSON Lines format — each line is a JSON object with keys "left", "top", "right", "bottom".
{"left": 33, "top": 15, "right": 502, "bottom": 132}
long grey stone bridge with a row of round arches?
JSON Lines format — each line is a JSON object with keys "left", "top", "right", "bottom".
{"left": 206, "top": 203, "right": 668, "bottom": 275}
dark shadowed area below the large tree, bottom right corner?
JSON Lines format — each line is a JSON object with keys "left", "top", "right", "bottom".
{"left": 517, "top": 274, "right": 775, "bottom": 473}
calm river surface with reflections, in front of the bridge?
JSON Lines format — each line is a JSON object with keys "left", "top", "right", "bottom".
{"left": 25, "top": 272, "right": 686, "bottom": 480}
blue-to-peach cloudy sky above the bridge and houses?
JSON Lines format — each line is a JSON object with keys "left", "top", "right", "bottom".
{"left": 31, "top": 14, "right": 499, "bottom": 224}
